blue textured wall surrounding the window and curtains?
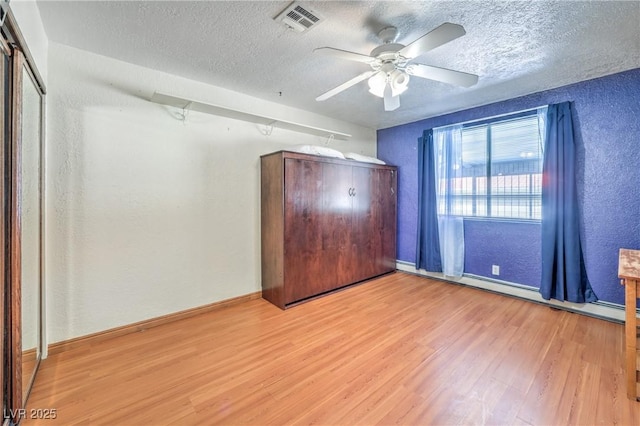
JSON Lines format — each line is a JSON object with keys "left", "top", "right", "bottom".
{"left": 378, "top": 69, "right": 640, "bottom": 304}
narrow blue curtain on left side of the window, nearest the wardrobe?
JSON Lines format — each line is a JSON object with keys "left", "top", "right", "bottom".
{"left": 416, "top": 129, "right": 442, "bottom": 272}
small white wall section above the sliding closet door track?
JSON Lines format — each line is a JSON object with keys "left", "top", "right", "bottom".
{"left": 9, "top": 0, "right": 49, "bottom": 85}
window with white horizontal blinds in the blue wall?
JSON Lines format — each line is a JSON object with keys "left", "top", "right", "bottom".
{"left": 439, "top": 111, "right": 543, "bottom": 220}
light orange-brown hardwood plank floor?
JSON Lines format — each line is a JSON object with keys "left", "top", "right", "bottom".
{"left": 24, "top": 273, "right": 640, "bottom": 425}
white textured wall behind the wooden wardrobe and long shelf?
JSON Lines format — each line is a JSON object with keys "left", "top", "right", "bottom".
{"left": 47, "top": 43, "right": 376, "bottom": 343}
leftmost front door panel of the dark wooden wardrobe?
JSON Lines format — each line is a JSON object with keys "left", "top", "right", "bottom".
{"left": 284, "top": 158, "right": 326, "bottom": 304}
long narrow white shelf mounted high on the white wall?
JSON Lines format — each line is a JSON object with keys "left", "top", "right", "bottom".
{"left": 150, "top": 92, "right": 351, "bottom": 140}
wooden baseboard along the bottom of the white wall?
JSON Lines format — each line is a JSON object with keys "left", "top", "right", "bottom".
{"left": 48, "top": 291, "right": 262, "bottom": 356}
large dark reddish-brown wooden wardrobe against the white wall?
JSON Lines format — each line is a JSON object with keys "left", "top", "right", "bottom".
{"left": 260, "top": 151, "right": 397, "bottom": 309}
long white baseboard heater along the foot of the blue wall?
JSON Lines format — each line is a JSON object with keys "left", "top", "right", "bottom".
{"left": 396, "top": 260, "right": 624, "bottom": 323}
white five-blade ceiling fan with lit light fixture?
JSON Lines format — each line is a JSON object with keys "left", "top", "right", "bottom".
{"left": 314, "top": 22, "right": 478, "bottom": 111}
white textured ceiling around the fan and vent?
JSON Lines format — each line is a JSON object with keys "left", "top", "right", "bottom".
{"left": 38, "top": 1, "right": 640, "bottom": 129}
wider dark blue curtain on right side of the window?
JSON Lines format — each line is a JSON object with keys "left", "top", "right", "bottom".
{"left": 540, "top": 102, "right": 598, "bottom": 303}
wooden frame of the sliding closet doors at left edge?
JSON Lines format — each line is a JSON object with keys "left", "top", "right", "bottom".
{"left": 0, "top": 5, "right": 46, "bottom": 425}
